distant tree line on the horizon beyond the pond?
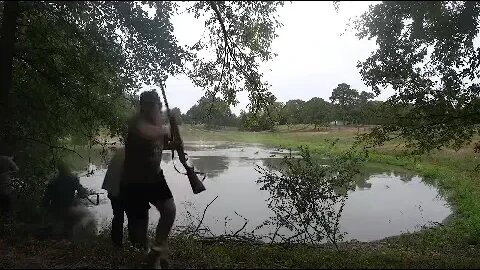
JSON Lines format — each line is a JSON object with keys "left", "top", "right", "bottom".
{"left": 178, "top": 83, "right": 386, "bottom": 131}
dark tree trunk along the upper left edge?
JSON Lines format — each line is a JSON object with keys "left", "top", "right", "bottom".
{"left": 0, "top": 1, "right": 19, "bottom": 150}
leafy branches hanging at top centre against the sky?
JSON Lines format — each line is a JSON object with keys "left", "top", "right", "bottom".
{"left": 187, "top": 1, "right": 283, "bottom": 112}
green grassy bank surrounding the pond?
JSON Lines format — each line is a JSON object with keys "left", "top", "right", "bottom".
{"left": 0, "top": 126, "right": 480, "bottom": 268}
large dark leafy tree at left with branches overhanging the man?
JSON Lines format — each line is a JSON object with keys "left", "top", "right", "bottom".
{"left": 0, "top": 1, "right": 282, "bottom": 202}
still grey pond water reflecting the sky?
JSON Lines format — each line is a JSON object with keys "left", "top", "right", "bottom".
{"left": 80, "top": 142, "right": 451, "bottom": 241}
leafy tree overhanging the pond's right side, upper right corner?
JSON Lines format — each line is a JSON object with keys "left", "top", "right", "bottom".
{"left": 355, "top": 1, "right": 480, "bottom": 153}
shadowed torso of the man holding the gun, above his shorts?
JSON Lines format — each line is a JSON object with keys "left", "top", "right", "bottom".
{"left": 124, "top": 117, "right": 163, "bottom": 183}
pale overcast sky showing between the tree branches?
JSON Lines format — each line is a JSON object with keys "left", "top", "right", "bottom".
{"left": 155, "top": 1, "right": 389, "bottom": 114}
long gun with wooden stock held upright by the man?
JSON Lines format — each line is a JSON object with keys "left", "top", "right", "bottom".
{"left": 160, "top": 83, "right": 205, "bottom": 194}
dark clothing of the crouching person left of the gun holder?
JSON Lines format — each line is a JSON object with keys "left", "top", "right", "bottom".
{"left": 45, "top": 174, "right": 87, "bottom": 209}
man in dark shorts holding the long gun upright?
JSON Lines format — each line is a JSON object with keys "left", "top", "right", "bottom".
{"left": 121, "top": 90, "right": 176, "bottom": 268}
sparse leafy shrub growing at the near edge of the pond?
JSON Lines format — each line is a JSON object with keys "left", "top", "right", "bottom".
{"left": 257, "top": 143, "right": 362, "bottom": 249}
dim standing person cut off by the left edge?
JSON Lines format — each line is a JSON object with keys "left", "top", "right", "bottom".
{"left": 0, "top": 152, "right": 18, "bottom": 219}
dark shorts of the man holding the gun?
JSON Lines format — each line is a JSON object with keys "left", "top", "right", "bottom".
{"left": 121, "top": 172, "right": 173, "bottom": 218}
